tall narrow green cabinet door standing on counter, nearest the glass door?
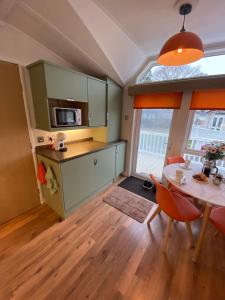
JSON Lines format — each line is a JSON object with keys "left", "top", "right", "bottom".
{"left": 107, "top": 84, "right": 122, "bottom": 142}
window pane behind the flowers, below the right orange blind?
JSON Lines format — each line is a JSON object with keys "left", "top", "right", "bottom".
{"left": 184, "top": 110, "right": 225, "bottom": 167}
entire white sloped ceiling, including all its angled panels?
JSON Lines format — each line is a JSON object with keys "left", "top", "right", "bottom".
{"left": 0, "top": 0, "right": 225, "bottom": 84}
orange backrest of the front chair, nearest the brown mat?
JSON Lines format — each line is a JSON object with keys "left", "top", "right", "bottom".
{"left": 150, "top": 174, "right": 180, "bottom": 220}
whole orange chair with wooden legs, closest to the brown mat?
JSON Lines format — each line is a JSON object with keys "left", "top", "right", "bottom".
{"left": 150, "top": 174, "right": 201, "bottom": 253}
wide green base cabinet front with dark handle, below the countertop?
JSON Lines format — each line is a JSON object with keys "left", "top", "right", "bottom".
{"left": 61, "top": 147, "right": 115, "bottom": 211}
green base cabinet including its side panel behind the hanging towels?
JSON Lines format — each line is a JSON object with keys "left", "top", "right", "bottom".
{"left": 37, "top": 146, "right": 116, "bottom": 219}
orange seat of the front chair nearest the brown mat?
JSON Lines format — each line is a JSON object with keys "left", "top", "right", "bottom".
{"left": 171, "top": 191, "right": 201, "bottom": 222}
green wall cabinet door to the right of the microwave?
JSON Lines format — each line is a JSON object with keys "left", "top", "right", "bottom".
{"left": 88, "top": 78, "right": 106, "bottom": 127}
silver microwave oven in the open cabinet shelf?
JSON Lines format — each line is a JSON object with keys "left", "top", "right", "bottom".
{"left": 50, "top": 107, "right": 82, "bottom": 127}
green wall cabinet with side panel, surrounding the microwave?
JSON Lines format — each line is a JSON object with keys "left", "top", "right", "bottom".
{"left": 27, "top": 61, "right": 88, "bottom": 131}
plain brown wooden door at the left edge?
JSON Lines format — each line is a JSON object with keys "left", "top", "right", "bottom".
{"left": 0, "top": 61, "right": 40, "bottom": 223}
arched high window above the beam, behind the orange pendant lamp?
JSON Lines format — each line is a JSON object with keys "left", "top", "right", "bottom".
{"left": 137, "top": 55, "right": 225, "bottom": 83}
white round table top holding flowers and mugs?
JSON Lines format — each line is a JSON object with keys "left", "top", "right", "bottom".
{"left": 163, "top": 164, "right": 225, "bottom": 206}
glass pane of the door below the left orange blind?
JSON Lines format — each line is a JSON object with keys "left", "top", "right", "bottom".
{"left": 134, "top": 109, "right": 173, "bottom": 178}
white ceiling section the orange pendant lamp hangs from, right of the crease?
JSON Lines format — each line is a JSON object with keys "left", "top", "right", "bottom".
{"left": 94, "top": 0, "right": 225, "bottom": 56}
